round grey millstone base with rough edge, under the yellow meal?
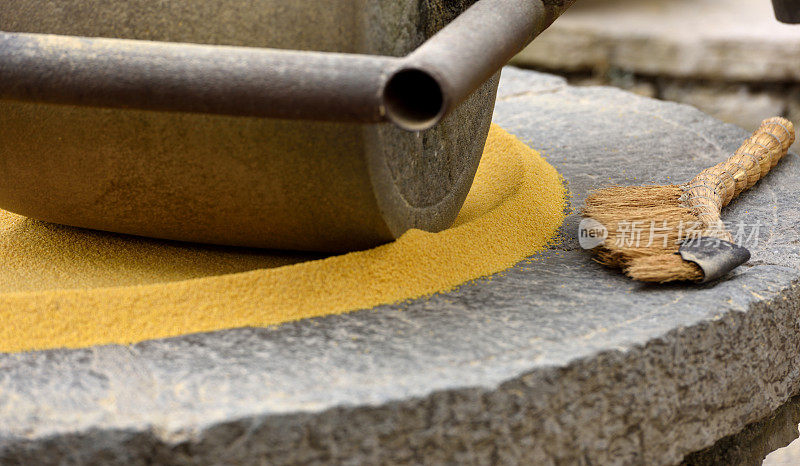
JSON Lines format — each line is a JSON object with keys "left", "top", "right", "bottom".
{"left": 0, "top": 69, "right": 800, "bottom": 465}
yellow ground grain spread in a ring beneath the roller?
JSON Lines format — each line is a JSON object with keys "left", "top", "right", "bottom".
{"left": 0, "top": 126, "right": 565, "bottom": 352}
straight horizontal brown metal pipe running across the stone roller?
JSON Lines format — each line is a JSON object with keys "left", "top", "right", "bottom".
{"left": 0, "top": 33, "right": 398, "bottom": 122}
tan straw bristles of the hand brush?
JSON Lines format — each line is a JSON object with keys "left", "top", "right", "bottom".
{"left": 583, "top": 185, "right": 703, "bottom": 282}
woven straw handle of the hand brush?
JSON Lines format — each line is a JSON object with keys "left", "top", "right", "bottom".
{"left": 682, "top": 117, "right": 795, "bottom": 242}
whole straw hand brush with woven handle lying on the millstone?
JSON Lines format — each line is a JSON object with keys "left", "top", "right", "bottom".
{"left": 581, "top": 117, "right": 795, "bottom": 283}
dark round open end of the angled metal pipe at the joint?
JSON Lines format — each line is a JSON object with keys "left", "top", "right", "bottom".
{"left": 383, "top": 68, "right": 445, "bottom": 131}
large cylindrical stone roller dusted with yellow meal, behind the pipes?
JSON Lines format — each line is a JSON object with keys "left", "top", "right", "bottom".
{"left": 0, "top": 0, "right": 497, "bottom": 252}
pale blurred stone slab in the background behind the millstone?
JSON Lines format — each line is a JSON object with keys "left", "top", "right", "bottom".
{"left": 517, "top": 0, "right": 800, "bottom": 82}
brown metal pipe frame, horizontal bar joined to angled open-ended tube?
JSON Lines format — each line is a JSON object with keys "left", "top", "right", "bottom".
{"left": 0, "top": 0, "right": 574, "bottom": 131}
